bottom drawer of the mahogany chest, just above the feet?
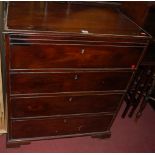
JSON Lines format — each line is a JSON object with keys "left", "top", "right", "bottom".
{"left": 9, "top": 115, "right": 113, "bottom": 139}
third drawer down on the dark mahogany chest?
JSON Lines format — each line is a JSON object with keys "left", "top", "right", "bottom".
{"left": 10, "top": 94, "right": 122, "bottom": 118}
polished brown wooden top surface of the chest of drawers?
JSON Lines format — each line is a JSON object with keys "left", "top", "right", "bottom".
{"left": 5, "top": 2, "right": 150, "bottom": 36}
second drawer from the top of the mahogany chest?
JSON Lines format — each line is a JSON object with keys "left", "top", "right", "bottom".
{"left": 10, "top": 71, "right": 132, "bottom": 94}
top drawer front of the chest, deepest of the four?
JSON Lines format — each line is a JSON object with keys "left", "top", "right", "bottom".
{"left": 11, "top": 44, "right": 143, "bottom": 69}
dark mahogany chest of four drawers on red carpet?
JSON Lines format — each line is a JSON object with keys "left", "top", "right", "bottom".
{"left": 0, "top": 2, "right": 150, "bottom": 146}
